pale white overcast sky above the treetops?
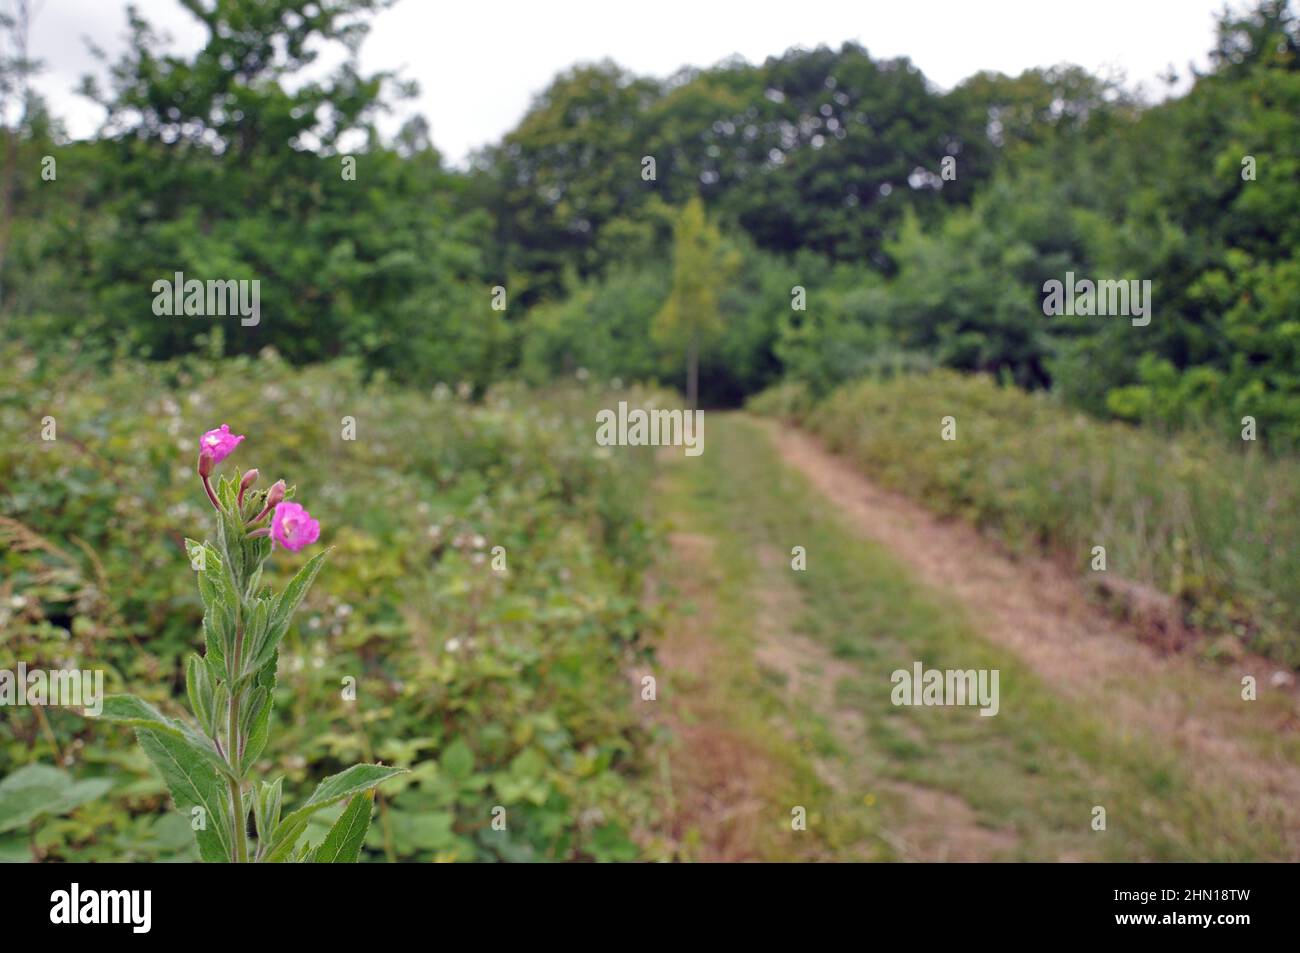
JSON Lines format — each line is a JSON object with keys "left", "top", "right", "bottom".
{"left": 22, "top": 0, "right": 1242, "bottom": 164}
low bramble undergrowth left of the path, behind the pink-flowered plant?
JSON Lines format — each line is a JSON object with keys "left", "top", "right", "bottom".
{"left": 0, "top": 346, "right": 654, "bottom": 861}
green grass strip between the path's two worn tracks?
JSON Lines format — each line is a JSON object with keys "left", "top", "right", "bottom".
{"left": 664, "top": 415, "right": 1283, "bottom": 861}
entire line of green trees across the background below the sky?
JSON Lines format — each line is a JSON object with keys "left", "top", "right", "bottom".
{"left": 0, "top": 0, "right": 1300, "bottom": 446}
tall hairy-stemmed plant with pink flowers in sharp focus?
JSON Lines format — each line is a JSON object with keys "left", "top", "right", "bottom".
{"left": 101, "top": 424, "right": 402, "bottom": 863}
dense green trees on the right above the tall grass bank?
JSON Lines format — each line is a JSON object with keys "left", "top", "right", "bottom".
{"left": 879, "top": 0, "right": 1300, "bottom": 450}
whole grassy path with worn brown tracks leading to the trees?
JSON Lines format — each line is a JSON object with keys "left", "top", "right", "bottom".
{"left": 644, "top": 413, "right": 1296, "bottom": 861}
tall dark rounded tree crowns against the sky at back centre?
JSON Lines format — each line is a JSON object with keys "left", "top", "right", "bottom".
{"left": 476, "top": 43, "right": 996, "bottom": 295}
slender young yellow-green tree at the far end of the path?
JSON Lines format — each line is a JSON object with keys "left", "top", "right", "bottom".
{"left": 651, "top": 198, "right": 740, "bottom": 410}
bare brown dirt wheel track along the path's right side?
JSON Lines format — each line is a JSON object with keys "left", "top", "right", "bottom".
{"left": 763, "top": 421, "right": 1300, "bottom": 857}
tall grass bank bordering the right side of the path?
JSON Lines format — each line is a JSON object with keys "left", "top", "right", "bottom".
{"left": 751, "top": 371, "right": 1300, "bottom": 666}
